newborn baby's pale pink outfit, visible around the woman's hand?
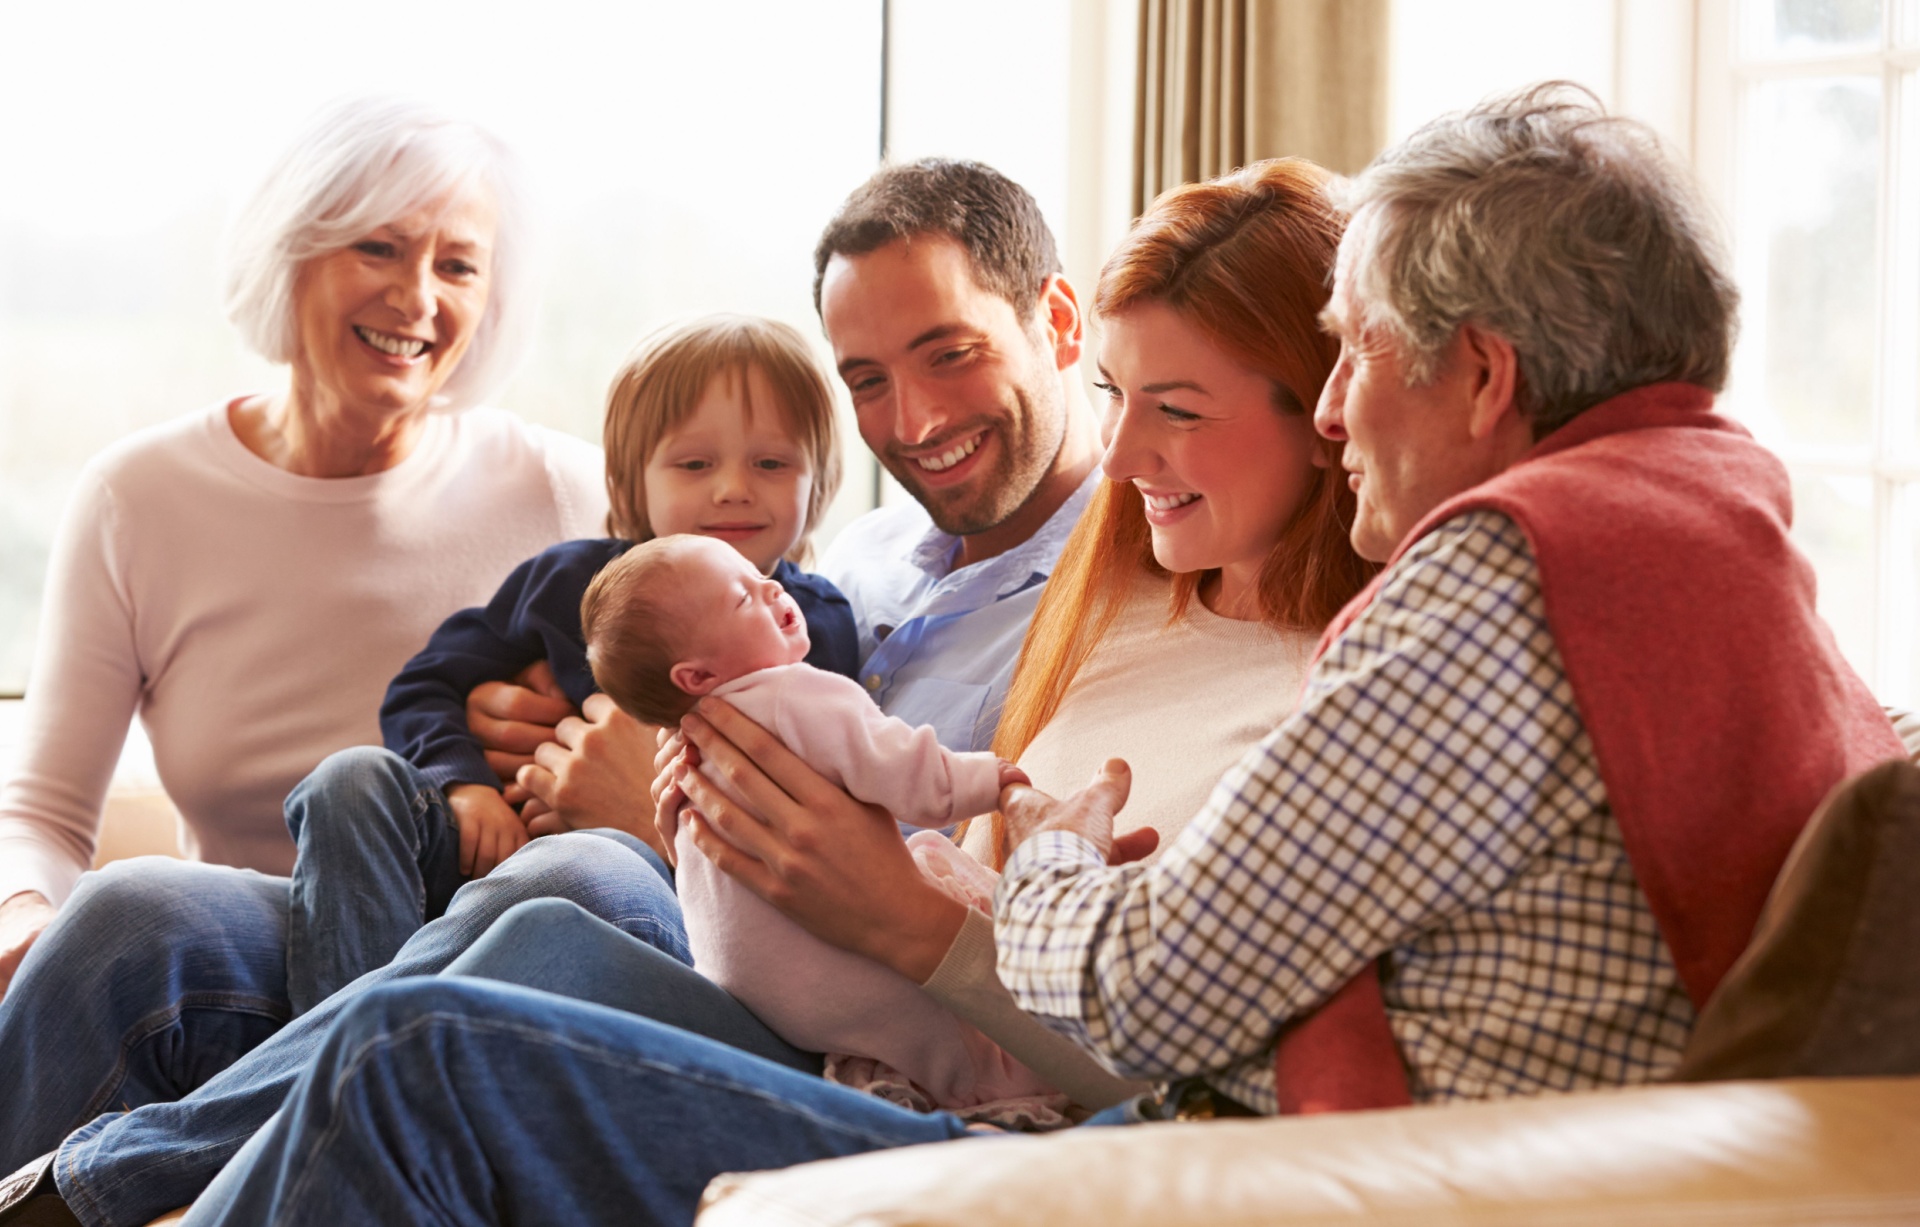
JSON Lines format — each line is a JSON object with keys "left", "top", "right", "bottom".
{"left": 674, "top": 664, "right": 1054, "bottom": 1108}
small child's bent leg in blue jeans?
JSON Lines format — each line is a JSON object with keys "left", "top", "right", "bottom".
{"left": 286, "top": 745, "right": 465, "bottom": 1014}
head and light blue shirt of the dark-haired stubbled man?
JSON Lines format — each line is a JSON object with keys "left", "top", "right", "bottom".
{"left": 814, "top": 159, "right": 1100, "bottom": 749}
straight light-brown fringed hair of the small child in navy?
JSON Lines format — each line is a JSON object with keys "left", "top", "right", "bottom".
{"left": 603, "top": 315, "right": 841, "bottom": 565}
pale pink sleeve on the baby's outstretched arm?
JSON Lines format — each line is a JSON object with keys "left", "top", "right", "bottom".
{"left": 744, "top": 664, "right": 1000, "bottom": 828}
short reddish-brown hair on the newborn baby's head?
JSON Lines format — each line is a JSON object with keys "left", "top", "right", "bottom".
{"left": 580, "top": 538, "right": 695, "bottom": 726}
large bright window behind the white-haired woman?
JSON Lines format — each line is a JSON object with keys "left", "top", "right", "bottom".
{"left": 0, "top": 0, "right": 881, "bottom": 695}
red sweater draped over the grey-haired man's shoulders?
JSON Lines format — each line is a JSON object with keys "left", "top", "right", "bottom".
{"left": 1275, "top": 384, "right": 1907, "bottom": 1112}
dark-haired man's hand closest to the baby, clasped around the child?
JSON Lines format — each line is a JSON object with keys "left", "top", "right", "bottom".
{"left": 516, "top": 695, "right": 664, "bottom": 854}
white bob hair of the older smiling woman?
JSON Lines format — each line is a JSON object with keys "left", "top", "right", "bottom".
{"left": 227, "top": 98, "right": 538, "bottom": 409}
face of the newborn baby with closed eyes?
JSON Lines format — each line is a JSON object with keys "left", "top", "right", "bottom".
{"left": 672, "top": 538, "right": 810, "bottom": 695}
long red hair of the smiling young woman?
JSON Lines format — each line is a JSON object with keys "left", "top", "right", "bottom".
{"left": 993, "top": 157, "right": 1377, "bottom": 866}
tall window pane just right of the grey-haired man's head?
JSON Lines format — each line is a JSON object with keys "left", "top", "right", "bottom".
{"left": 1736, "top": 77, "right": 1880, "bottom": 447}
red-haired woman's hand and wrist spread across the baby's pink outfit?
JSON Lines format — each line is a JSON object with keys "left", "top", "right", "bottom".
{"left": 679, "top": 699, "right": 966, "bottom": 983}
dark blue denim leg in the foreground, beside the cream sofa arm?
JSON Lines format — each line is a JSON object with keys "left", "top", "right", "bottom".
{"left": 186, "top": 977, "right": 983, "bottom": 1227}
